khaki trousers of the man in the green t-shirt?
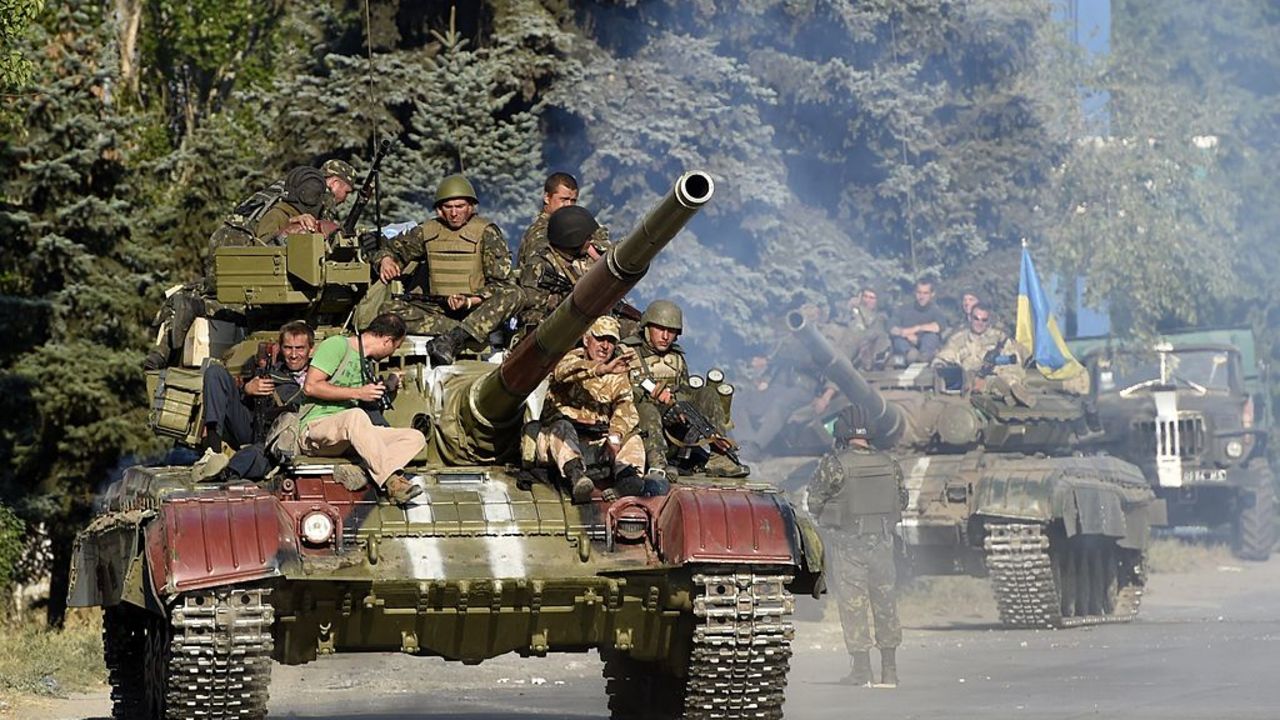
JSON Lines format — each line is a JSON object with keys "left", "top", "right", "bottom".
{"left": 302, "top": 407, "right": 426, "bottom": 487}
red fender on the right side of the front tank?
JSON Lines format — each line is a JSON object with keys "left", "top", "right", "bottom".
{"left": 655, "top": 486, "right": 798, "bottom": 568}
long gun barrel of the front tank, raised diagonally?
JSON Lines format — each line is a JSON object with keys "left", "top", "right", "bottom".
{"left": 470, "top": 170, "right": 716, "bottom": 425}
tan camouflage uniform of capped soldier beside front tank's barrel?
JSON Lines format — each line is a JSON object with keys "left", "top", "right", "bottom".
{"left": 536, "top": 347, "right": 644, "bottom": 474}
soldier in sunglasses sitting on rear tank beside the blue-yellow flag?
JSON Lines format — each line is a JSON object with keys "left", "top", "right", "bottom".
{"left": 933, "top": 302, "right": 1036, "bottom": 407}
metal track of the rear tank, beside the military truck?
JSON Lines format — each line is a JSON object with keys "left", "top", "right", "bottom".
{"left": 983, "top": 523, "right": 1142, "bottom": 628}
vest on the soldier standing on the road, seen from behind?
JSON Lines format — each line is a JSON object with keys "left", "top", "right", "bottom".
{"left": 818, "top": 450, "right": 902, "bottom": 534}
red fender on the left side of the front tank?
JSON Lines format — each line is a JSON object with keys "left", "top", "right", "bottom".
{"left": 146, "top": 488, "right": 300, "bottom": 597}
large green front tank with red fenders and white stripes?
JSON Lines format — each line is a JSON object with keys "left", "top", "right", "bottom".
{"left": 69, "top": 172, "right": 822, "bottom": 719}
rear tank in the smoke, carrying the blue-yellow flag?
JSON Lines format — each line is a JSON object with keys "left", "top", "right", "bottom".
{"left": 787, "top": 313, "right": 1164, "bottom": 628}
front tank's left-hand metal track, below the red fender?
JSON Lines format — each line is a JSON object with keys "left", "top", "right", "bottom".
{"left": 157, "top": 588, "right": 274, "bottom": 720}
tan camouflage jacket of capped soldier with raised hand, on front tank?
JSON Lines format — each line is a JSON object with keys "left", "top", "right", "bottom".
{"left": 543, "top": 347, "right": 640, "bottom": 438}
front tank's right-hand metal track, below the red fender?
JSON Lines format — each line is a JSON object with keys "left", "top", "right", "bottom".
{"left": 684, "top": 569, "right": 795, "bottom": 720}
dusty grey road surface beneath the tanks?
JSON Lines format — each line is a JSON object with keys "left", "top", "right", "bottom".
{"left": 22, "top": 548, "right": 1280, "bottom": 720}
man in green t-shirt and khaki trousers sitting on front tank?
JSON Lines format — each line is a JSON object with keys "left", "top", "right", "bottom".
{"left": 301, "top": 313, "right": 426, "bottom": 505}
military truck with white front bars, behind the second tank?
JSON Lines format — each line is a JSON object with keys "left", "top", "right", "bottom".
{"left": 1073, "top": 328, "right": 1276, "bottom": 561}
